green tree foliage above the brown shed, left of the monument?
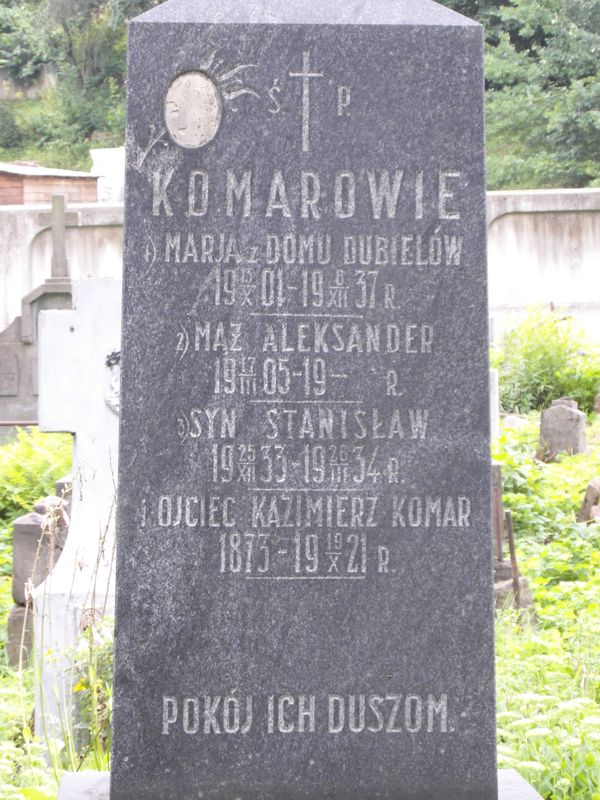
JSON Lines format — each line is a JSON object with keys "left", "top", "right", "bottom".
{"left": 0, "top": 0, "right": 158, "bottom": 166}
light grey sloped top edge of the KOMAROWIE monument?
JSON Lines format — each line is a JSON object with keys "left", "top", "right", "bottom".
{"left": 133, "top": 0, "right": 481, "bottom": 28}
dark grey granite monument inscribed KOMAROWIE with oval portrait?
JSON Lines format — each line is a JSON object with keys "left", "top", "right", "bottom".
{"left": 111, "top": 0, "right": 497, "bottom": 800}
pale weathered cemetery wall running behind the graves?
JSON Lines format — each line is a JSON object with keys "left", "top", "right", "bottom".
{"left": 0, "top": 189, "right": 600, "bottom": 340}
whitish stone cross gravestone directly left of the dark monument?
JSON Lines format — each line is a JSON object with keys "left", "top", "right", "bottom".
{"left": 34, "top": 278, "right": 121, "bottom": 738}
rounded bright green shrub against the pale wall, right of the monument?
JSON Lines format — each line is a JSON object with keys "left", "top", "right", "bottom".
{"left": 492, "top": 311, "right": 600, "bottom": 413}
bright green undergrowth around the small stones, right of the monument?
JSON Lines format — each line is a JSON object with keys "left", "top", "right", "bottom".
{"left": 494, "top": 415, "right": 600, "bottom": 800}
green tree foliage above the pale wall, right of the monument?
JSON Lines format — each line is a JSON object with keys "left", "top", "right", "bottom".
{"left": 447, "top": 0, "right": 600, "bottom": 188}
